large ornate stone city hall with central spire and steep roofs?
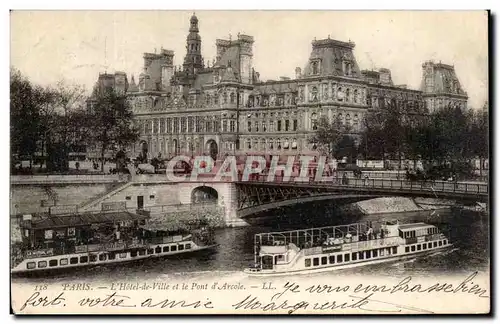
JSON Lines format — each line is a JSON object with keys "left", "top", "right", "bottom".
{"left": 91, "top": 15, "right": 468, "bottom": 158}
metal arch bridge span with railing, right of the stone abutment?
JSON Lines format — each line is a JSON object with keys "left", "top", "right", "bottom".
{"left": 236, "top": 178, "right": 489, "bottom": 218}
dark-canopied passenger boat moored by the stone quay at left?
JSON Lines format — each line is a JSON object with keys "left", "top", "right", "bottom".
{"left": 11, "top": 210, "right": 217, "bottom": 274}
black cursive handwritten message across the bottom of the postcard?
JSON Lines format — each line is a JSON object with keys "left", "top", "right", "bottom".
{"left": 20, "top": 272, "right": 489, "bottom": 314}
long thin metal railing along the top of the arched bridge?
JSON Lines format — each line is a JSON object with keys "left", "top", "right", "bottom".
{"left": 248, "top": 175, "right": 488, "bottom": 194}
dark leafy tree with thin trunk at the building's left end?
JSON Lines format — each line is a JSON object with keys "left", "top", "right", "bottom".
{"left": 88, "top": 89, "right": 139, "bottom": 171}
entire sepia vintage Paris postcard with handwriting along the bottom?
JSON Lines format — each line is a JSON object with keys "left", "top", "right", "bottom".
{"left": 10, "top": 10, "right": 491, "bottom": 315}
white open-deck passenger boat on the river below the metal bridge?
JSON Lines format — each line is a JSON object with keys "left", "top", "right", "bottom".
{"left": 244, "top": 221, "right": 452, "bottom": 276}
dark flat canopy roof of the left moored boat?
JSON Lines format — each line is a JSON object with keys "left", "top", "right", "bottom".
{"left": 22, "top": 211, "right": 149, "bottom": 229}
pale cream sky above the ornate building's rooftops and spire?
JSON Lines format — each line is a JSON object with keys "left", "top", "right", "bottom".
{"left": 10, "top": 11, "right": 488, "bottom": 109}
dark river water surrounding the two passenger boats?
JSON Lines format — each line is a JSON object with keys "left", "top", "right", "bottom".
{"left": 13, "top": 202, "right": 490, "bottom": 284}
